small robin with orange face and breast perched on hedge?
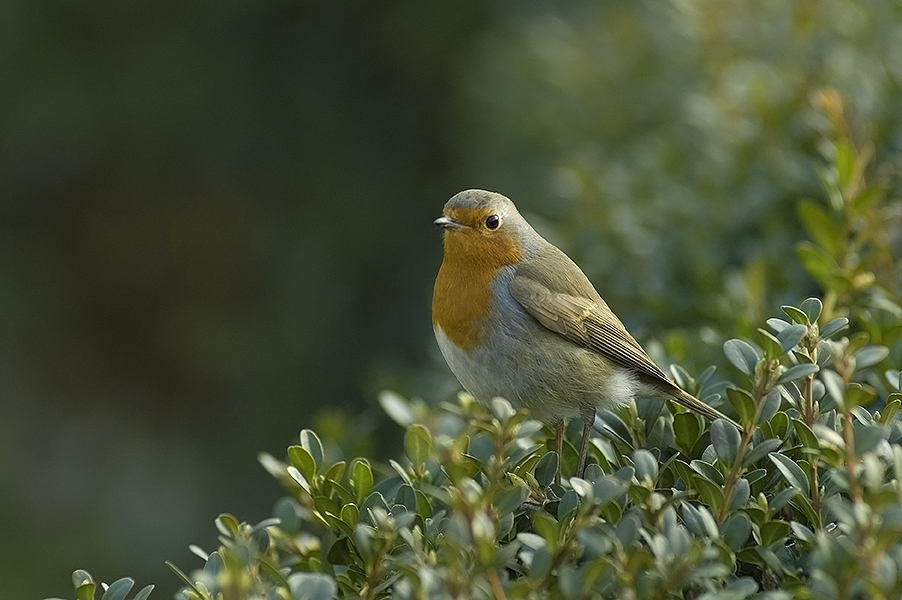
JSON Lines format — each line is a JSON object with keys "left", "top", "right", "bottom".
{"left": 432, "top": 190, "right": 735, "bottom": 476}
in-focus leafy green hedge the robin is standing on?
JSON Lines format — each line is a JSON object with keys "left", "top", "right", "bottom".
{"left": 51, "top": 101, "right": 902, "bottom": 600}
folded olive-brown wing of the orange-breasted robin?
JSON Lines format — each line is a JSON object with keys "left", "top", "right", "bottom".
{"left": 510, "top": 271, "right": 673, "bottom": 387}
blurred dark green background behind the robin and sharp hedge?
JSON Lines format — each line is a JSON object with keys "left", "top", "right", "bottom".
{"left": 0, "top": 0, "right": 902, "bottom": 598}
